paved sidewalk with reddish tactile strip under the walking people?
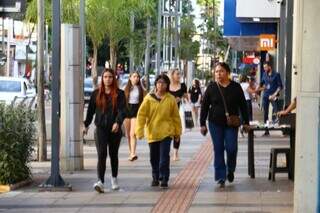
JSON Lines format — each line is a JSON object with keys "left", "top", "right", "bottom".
{"left": 0, "top": 105, "right": 293, "bottom": 213}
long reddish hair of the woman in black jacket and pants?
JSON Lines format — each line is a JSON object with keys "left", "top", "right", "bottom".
{"left": 96, "top": 68, "right": 118, "bottom": 112}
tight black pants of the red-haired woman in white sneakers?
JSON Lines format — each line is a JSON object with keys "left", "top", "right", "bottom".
{"left": 95, "top": 127, "right": 122, "bottom": 183}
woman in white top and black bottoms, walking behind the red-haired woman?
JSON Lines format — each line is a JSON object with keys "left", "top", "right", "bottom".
{"left": 124, "top": 71, "right": 145, "bottom": 161}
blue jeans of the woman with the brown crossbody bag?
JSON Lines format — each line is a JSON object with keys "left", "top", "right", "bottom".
{"left": 209, "top": 122, "right": 238, "bottom": 181}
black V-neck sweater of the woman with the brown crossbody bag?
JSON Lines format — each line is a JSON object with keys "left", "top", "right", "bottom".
{"left": 200, "top": 81, "right": 249, "bottom": 126}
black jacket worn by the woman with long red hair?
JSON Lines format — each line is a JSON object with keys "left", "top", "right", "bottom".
{"left": 84, "top": 89, "right": 126, "bottom": 130}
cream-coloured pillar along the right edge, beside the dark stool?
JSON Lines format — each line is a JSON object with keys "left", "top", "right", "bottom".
{"left": 293, "top": 0, "right": 320, "bottom": 212}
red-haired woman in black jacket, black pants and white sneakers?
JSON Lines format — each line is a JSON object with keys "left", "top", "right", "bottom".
{"left": 84, "top": 69, "right": 126, "bottom": 193}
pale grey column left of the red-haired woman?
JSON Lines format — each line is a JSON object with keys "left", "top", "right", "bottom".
{"left": 60, "top": 24, "right": 83, "bottom": 171}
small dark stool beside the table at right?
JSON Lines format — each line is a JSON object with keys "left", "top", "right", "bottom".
{"left": 268, "top": 148, "right": 291, "bottom": 181}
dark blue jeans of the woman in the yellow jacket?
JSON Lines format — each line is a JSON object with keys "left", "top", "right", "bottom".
{"left": 149, "top": 137, "right": 172, "bottom": 181}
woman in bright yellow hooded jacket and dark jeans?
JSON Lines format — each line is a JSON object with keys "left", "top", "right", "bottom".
{"left": 135, "top": 74, "right": 181, "bottom": 188}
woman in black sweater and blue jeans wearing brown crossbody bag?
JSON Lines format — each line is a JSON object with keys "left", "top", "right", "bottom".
{"left": 200, "top": 62, "right": 249, "bottom": 187}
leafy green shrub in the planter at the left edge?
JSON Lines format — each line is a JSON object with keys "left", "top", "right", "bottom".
{"left": 0, "top": 104, "right": 36, "bottom": 184}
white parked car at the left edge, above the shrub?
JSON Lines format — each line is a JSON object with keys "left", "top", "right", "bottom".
{"left": 0, "top": 77, "right": 36, "bottom": 105}
